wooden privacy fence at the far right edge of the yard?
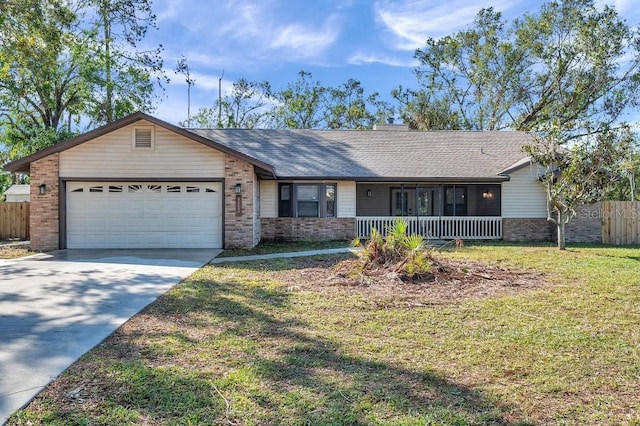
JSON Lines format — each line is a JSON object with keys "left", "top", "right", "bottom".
{"left": 602, "top": 201, "right": 640, "bottom": 245}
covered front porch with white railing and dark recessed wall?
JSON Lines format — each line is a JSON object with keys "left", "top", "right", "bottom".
{"left": 356, "top": 182, "right": 502, "bottom": 240}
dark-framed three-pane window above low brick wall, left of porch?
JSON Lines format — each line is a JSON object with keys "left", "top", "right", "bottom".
{"left": 278, "top": 183, "right": 337, "bottom": 217}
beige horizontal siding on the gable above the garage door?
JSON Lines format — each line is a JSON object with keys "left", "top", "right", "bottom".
{"left": 60, "top": 122, "right": 224, "bottom": 178}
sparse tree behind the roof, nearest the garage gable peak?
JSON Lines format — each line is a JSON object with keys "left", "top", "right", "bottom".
{"left": 186, "top": 78, "right": 273, "bottom": 129}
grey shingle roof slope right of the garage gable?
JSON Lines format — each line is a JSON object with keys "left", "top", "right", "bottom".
{"left": 190, "top": 129, "right": 532, "bottom": 180}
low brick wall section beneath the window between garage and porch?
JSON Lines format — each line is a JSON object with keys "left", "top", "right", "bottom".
{"left": 261, "top": 217, "right": 356, "bottom": 241}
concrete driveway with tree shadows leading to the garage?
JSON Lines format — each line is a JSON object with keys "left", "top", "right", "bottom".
{"left": 0, "top": 249, "right": 220, "bottom": 424}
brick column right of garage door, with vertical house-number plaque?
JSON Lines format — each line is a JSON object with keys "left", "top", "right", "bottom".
{"left": 224, "top": 154, "right": 255, "bottom": 248}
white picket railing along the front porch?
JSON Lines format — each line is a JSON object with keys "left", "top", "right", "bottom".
{"left": 356, "top": 216, "right": 502, "bottom": 240}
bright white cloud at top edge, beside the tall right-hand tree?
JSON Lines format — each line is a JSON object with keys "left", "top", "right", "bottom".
{"left": 374, "top": 0, "right": 514, "bottom": 50}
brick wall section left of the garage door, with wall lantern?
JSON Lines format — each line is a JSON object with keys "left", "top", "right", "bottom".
{"left": 29, "top": 153, "right": 60, "bottom": 251}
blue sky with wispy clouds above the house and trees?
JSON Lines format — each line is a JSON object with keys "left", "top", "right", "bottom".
{"left": 145, "top": 0, "right": 640, "bottom": 124}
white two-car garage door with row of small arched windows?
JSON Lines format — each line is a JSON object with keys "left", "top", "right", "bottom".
{"left": 66, "top": 182, "right": 222, "bottom": 248}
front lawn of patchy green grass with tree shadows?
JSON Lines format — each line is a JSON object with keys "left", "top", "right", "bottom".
{"left": 9, "top": 244, "right": 640, "bottom": 425}
